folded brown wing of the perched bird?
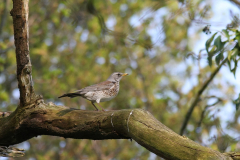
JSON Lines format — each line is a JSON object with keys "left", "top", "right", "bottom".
{"left": 74, "top": 81, "right": 115, "bottom": 94}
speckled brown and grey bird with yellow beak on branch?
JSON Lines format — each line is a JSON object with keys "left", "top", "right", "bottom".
{"left": 58, "top": 72, "right": 128, "bottom": 111}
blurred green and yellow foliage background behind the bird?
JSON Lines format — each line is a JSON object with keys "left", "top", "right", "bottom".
{"left": 0, "top": 0, "right": 239, "bottom": 159}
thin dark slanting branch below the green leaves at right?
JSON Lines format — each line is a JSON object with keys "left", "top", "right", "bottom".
{"left": 180, "top": 58, "right": 228, "bottom": 135}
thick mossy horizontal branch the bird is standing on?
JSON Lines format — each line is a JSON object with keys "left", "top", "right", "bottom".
{"left": 0, "top": 100, "right": 232, "bottom": 160}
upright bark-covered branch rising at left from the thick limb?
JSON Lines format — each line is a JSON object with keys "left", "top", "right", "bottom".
{"left": 10, "top": 0, "right": 41, "bottom": 107}
